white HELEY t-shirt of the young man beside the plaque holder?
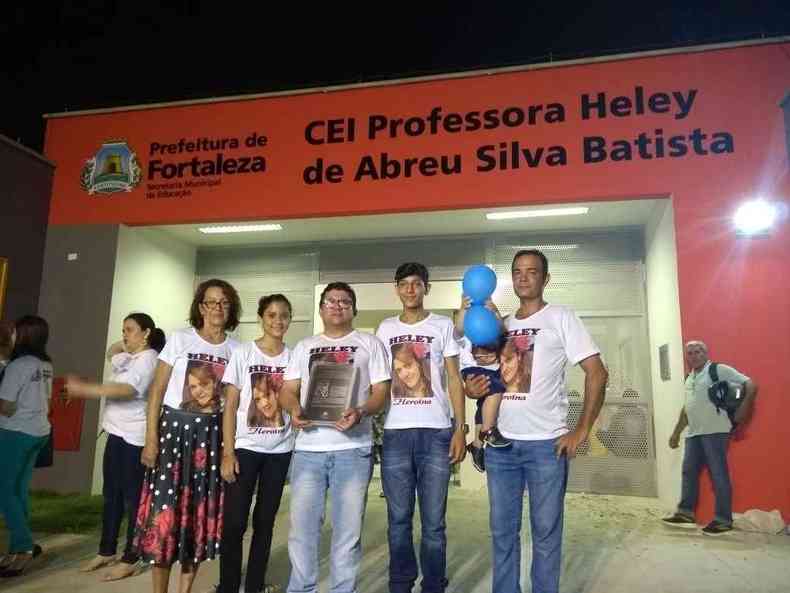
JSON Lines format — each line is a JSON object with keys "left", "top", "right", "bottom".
{"left": 376, "top": 313, "right": 459, "bottom": 429}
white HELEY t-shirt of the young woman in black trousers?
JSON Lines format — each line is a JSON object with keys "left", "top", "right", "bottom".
{"left": 222, "top": 342, "right": 293, "bottom": 453}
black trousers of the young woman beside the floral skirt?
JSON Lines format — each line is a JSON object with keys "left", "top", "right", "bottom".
{"left": 218, "top": 449, "right": 291, "bottom": 593}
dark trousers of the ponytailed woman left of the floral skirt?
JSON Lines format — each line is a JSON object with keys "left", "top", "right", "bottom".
{"left": 99, "top": 434, "right": 145, "bottom": 564}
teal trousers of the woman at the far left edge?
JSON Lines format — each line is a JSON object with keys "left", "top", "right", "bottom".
{"left": 0, "top": 428, "right": 50, "bottom": 554}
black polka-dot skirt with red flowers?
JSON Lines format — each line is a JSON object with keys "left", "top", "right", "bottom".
{"left": 134, "top": 406, "right": 223, "bottom": 566}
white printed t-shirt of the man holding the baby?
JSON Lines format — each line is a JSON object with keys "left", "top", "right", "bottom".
{"left": 497, "top": 304, "right": 600, "bottom": 441}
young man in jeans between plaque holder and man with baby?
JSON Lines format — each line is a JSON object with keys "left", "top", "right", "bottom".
{"left": 376, "top": 262, "right": 469, "bottom": 593}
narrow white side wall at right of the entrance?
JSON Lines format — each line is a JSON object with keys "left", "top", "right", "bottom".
{"left": 645, "top": 200, "right": 684, "bottom": 510}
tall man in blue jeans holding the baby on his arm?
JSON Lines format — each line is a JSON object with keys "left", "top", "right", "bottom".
{"left": 466, "top": 249, "right": 608, "bottom": 593}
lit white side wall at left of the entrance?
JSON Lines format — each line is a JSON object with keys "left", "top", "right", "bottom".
{"left": 92, "top": 226, "right": 196, "bottom": 493}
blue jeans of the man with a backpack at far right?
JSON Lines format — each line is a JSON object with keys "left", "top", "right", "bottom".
{"left": 678, "top": 432, "right": 732, "bottom": 525}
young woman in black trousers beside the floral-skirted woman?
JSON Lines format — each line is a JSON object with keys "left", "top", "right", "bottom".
{"left": 209, "top": 294, "right": 293, "bottom": 593}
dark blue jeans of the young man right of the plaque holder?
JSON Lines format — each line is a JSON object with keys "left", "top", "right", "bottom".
{"left": 381, "top": 428, "right": 453, "bottom": 593}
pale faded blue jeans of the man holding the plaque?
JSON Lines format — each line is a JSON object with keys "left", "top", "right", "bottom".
{"left": 288, "top": 447, "right": 373, "bottom": 593}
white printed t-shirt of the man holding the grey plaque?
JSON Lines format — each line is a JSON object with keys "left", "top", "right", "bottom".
{"left": 284, "top": 330, "right": 390, "bottom": 451}
